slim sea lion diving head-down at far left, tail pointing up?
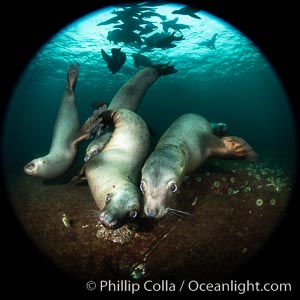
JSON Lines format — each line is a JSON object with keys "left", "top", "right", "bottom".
{"left": 24, "top": 63, "right": 84, "bottom": 179}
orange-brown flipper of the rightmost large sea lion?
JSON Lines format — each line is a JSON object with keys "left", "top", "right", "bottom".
{"left": 212, "top": 136, "right": 259, "bottom": 162}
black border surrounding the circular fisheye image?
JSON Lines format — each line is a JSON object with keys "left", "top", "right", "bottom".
{"left": 0, "top": 0, "right": 299, "bottom": 297}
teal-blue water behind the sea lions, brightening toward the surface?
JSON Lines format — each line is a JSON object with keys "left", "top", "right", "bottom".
{"left": 3, "top": 5, "right": 296, "bottom": 177}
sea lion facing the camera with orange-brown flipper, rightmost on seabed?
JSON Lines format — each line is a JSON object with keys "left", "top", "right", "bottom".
{"left": 140, "top": 113, "right": 258, "bottom": 218}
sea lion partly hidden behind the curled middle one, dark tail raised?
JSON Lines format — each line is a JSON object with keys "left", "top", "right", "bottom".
{"left": 85, "top": 63, "right": 178, "bottom": 161}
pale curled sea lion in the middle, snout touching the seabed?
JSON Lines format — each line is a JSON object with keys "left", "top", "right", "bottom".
{"left": 85, "top": 109, "right": 150, "bottom": 229}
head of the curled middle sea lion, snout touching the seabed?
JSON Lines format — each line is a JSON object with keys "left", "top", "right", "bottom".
{"left": 100, "top": 183, "right": 141, "bottom": 229}
